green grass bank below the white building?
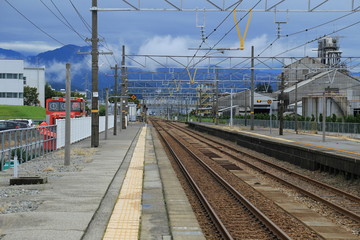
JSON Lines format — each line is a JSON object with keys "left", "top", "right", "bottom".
{"left": 0, "top": 105, "right": 46, "bottom": 120}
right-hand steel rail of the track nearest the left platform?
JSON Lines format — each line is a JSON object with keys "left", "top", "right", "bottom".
{"left": 155, "top": 120, "right": 291, "bottom": 239}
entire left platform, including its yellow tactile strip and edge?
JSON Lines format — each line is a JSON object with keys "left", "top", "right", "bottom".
{"left": 0, "top": 123, "right": 205, "bottom": 240}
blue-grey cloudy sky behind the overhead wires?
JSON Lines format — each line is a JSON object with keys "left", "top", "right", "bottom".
{"left": 0, "top": 0, "right": 360, "bottom": 71}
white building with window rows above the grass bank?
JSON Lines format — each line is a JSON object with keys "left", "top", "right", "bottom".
{"left": 0, "top": 59, "right": 45, "bottom": 107}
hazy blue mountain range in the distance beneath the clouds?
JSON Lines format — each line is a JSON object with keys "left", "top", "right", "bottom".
{"left": 0, "top": 45, "right": 258, "bottom": 95}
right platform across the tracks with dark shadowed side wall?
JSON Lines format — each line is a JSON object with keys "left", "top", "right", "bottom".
{"left": 188, "top": 122, "right": 360, "bottom": 179}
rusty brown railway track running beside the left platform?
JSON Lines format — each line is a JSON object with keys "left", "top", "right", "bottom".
{"left": 152, "top": 121, "right": 320, "bottom": 239}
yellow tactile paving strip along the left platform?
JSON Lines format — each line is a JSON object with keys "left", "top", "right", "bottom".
{"left": 103, "top": 127, "right": 146, "bottom": 240}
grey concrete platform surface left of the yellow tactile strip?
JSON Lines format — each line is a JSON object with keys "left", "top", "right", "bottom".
{"left": 0, "top": 124, "right": 144, "bottom": 240}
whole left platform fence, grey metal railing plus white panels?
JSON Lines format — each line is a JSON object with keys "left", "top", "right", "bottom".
{"left": 0, "top": 116, "right": 114, "bottom": 171}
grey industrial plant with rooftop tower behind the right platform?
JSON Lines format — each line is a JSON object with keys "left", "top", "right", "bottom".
{"left": 219, "top": 37, "right": 360, "bottom": 118}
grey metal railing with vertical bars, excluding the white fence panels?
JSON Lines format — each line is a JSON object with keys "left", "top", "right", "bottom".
{"left": 0, "top": 125, "right": 57, "bottom": 171}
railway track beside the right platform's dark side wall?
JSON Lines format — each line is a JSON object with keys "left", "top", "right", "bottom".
{"left": 169, "top": 123, "right": 360, "bottom": 223}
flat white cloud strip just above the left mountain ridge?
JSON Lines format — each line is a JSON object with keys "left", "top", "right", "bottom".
{"left": 0, "top": 41, "right": 60, "bottom": 54}
